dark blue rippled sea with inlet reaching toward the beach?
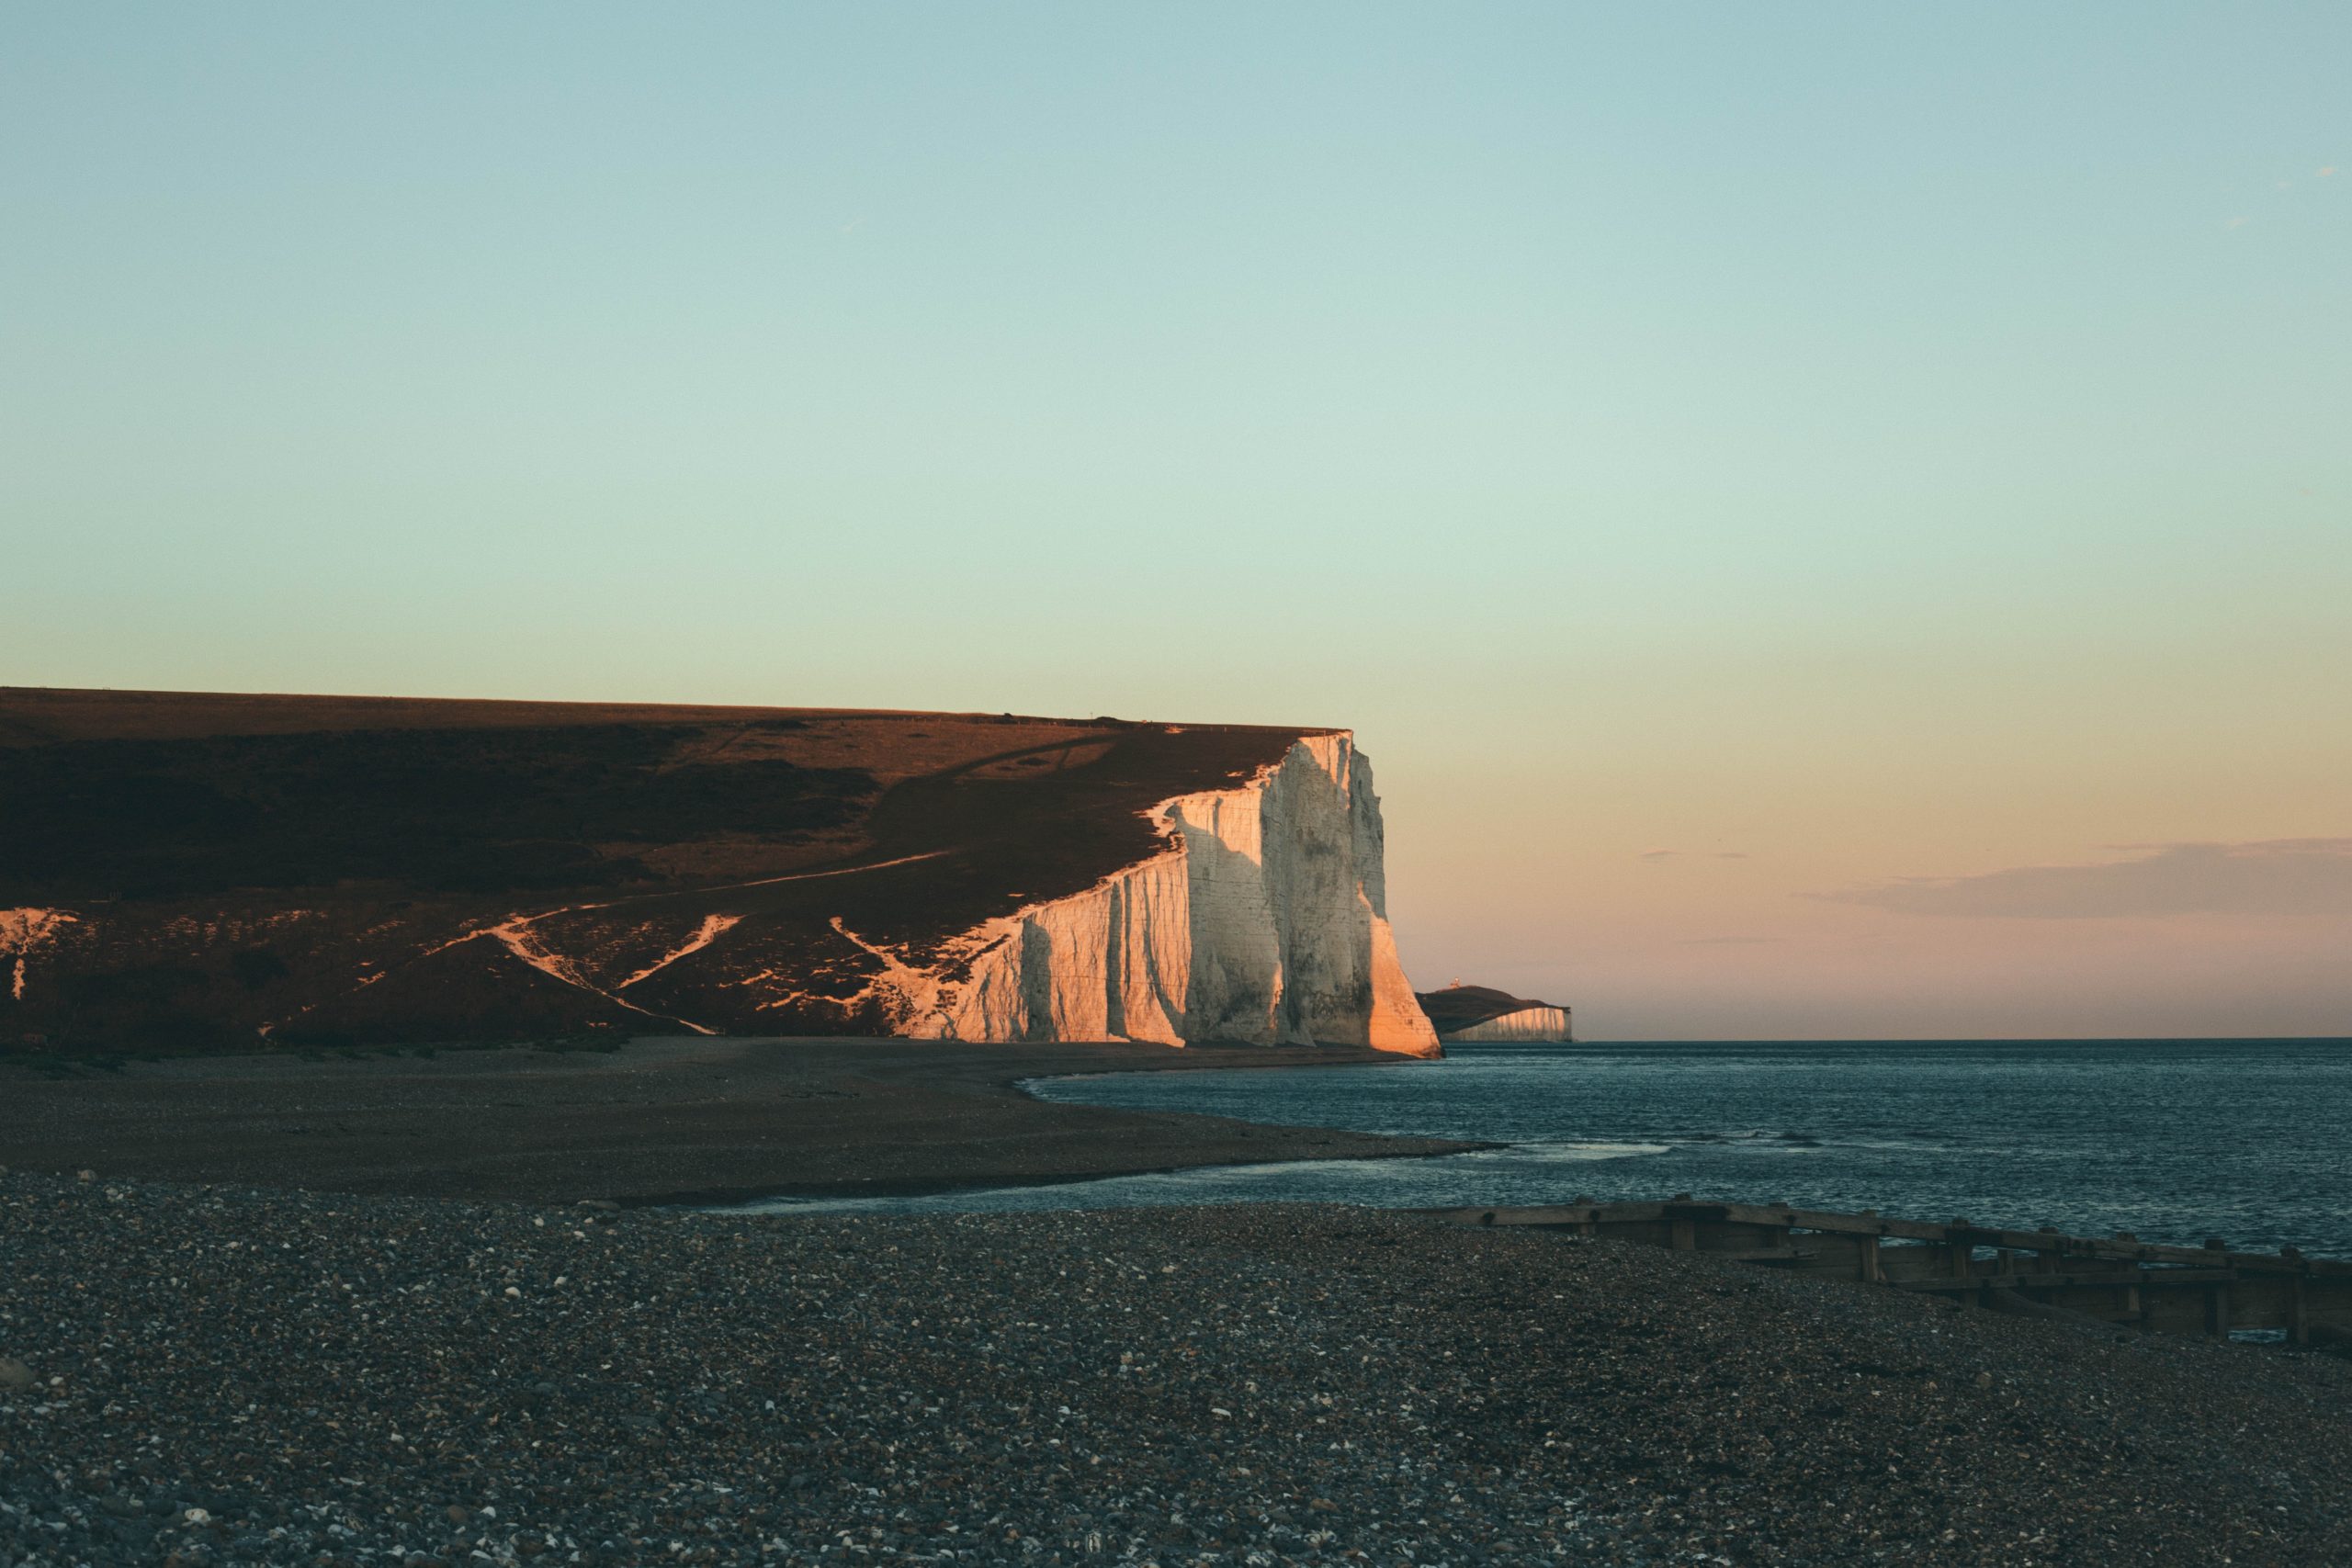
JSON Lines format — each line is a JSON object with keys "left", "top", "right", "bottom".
{"left": 719, "top": 1039, "right": 2352, "bottom": 1258}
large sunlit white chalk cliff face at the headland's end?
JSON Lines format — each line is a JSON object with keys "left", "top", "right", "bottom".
{"left": 870, "top": 731, "right": 1440, "bottom": 1055}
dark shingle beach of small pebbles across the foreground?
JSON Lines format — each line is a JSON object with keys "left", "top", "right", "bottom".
{"left": 0, "top": 1173, "right": 2352, "bottom": 1568}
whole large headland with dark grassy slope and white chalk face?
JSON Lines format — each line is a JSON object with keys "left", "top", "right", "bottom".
{"left": 0, "top": 689, "right": 1437, "bottom": 1055}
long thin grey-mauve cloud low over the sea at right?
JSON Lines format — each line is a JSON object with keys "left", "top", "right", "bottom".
{"left": 1811, "top": 840, "right": 2352, "bottom": 919}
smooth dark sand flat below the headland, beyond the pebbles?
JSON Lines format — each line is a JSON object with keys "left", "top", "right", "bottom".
{"left": 0, "top": 1039, "right": 1482, "bottom": 1203}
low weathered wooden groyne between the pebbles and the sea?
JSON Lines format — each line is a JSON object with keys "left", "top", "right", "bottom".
{"left": 1432, "top": 1192, "right": 2352, "bottom": 1347}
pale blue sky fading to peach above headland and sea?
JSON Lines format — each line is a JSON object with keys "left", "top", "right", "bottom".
{"left": 0, "top": 0, "right": 2352, "bottom": 1039}
